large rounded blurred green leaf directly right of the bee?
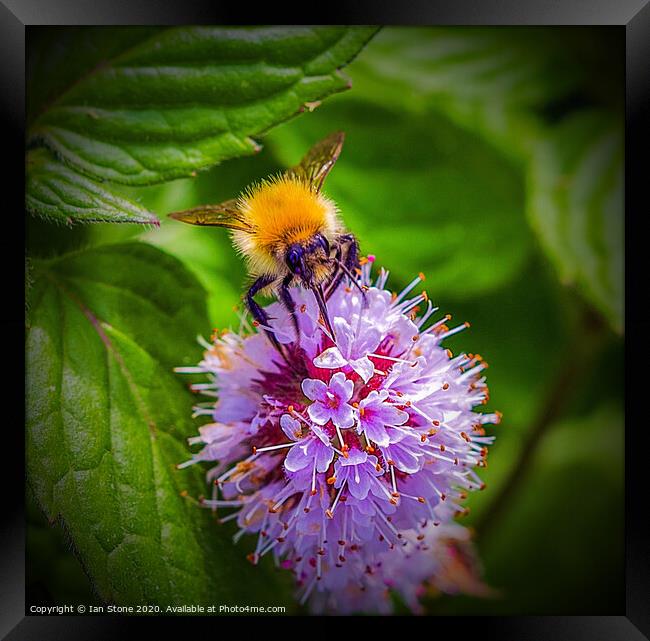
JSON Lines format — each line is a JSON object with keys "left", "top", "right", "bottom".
{"left": 266, "top": 96, "right": 533, "bottom": 303}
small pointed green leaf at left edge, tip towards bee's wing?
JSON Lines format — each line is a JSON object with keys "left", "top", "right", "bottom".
{"left": 25, "top": 149, "right": 158, "bottom": 225}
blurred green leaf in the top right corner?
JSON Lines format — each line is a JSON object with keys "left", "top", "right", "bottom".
{"left": 350, "top": 27, "right": 624, "bottom": 159}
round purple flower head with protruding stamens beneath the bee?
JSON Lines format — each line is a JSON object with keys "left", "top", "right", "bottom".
{"left": 178, "top": 260, "right": 500, "bottom": 613}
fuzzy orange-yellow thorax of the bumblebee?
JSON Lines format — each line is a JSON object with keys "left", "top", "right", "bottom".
{"left": 233, "top": 176, "right": 339, "bottom": 274}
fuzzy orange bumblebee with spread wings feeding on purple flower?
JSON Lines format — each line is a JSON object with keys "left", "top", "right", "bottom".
{"left": 169, "top": 131, "right": 359, "bottom": 354}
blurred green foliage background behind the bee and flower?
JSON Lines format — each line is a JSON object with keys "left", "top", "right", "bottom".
{"left": 27, "top": 27, "right": 624, "bottom": 614}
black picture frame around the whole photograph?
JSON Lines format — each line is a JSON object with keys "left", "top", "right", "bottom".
{"left": 0, "top": 0, "right": 650, "bottom": 641}
